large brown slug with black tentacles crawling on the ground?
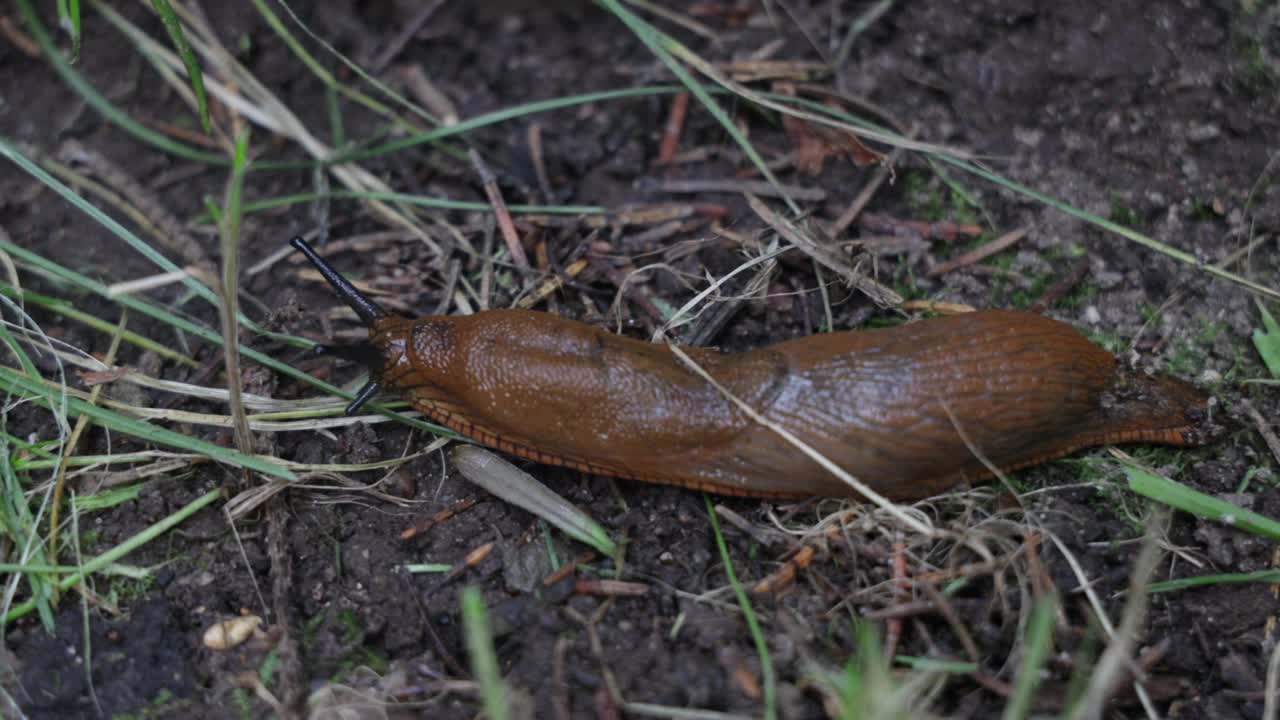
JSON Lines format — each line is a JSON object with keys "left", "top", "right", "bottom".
{"left": 292, "top": 238, "right": 1211, "bottom": 500}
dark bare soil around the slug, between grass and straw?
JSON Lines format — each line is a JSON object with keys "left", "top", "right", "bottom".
{"left": 0, "top": 0, "right": 1280, "bottom": 717}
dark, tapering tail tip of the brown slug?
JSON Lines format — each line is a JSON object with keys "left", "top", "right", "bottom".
{"left": 1098, "top": 366, "right": 1231, "bottom": 445}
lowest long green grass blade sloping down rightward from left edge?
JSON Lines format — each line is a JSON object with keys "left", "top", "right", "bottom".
{"left": 0, "top": 365, "right": 296, "bottom": 480}
